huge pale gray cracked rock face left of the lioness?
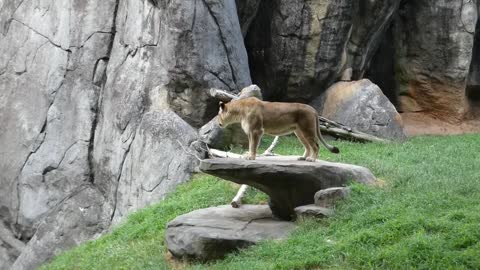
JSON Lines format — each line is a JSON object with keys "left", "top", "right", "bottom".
{"left": 0, "top": 0, "right": 251, "bottom": 268}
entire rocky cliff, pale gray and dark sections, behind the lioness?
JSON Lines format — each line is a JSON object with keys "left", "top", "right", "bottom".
{"left": 0, "top": 0, "right": 480, "bottom": 269}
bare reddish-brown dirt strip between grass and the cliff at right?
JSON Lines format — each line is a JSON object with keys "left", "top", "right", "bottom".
{"left": 401, "top": 113, "right": 480, "bottom": 136}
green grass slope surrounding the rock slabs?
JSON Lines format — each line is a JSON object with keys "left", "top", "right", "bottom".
{"left": 44, "top": 135, "right": 480, "bottom": 270}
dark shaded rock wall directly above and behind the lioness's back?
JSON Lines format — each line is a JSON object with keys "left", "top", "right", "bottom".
{"left": 245, "top": 0, "right": 356, "bottom": 102}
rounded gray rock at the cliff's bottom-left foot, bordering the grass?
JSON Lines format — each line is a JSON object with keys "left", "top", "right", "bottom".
{"left": 12, "top": 184, "right": 111, "bottom": 270}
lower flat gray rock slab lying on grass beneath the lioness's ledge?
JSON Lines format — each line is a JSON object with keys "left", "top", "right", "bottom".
{"left": 165, "top": 205, "right": 296, "bottom": 260}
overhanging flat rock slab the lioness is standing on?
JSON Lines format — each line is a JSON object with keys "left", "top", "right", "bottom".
{"left": 200, "top": 156, "right": 375, "bottom": 220}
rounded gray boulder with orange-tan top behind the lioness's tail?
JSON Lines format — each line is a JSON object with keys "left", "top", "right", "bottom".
{"left": 311, "top": 79, "right": 406, "bottom": 140}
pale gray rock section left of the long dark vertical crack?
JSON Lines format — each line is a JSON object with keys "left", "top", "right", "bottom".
{"left": 0, "top": 1, "right": 115, "bottom": 268}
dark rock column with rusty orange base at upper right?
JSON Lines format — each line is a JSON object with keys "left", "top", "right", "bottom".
{"left": 395, "top": 0, "right": 477, "bottom": 120}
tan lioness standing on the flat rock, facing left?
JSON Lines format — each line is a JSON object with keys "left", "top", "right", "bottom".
{"left": 218, "top": 97, "right": 339, "bottom": 161}
